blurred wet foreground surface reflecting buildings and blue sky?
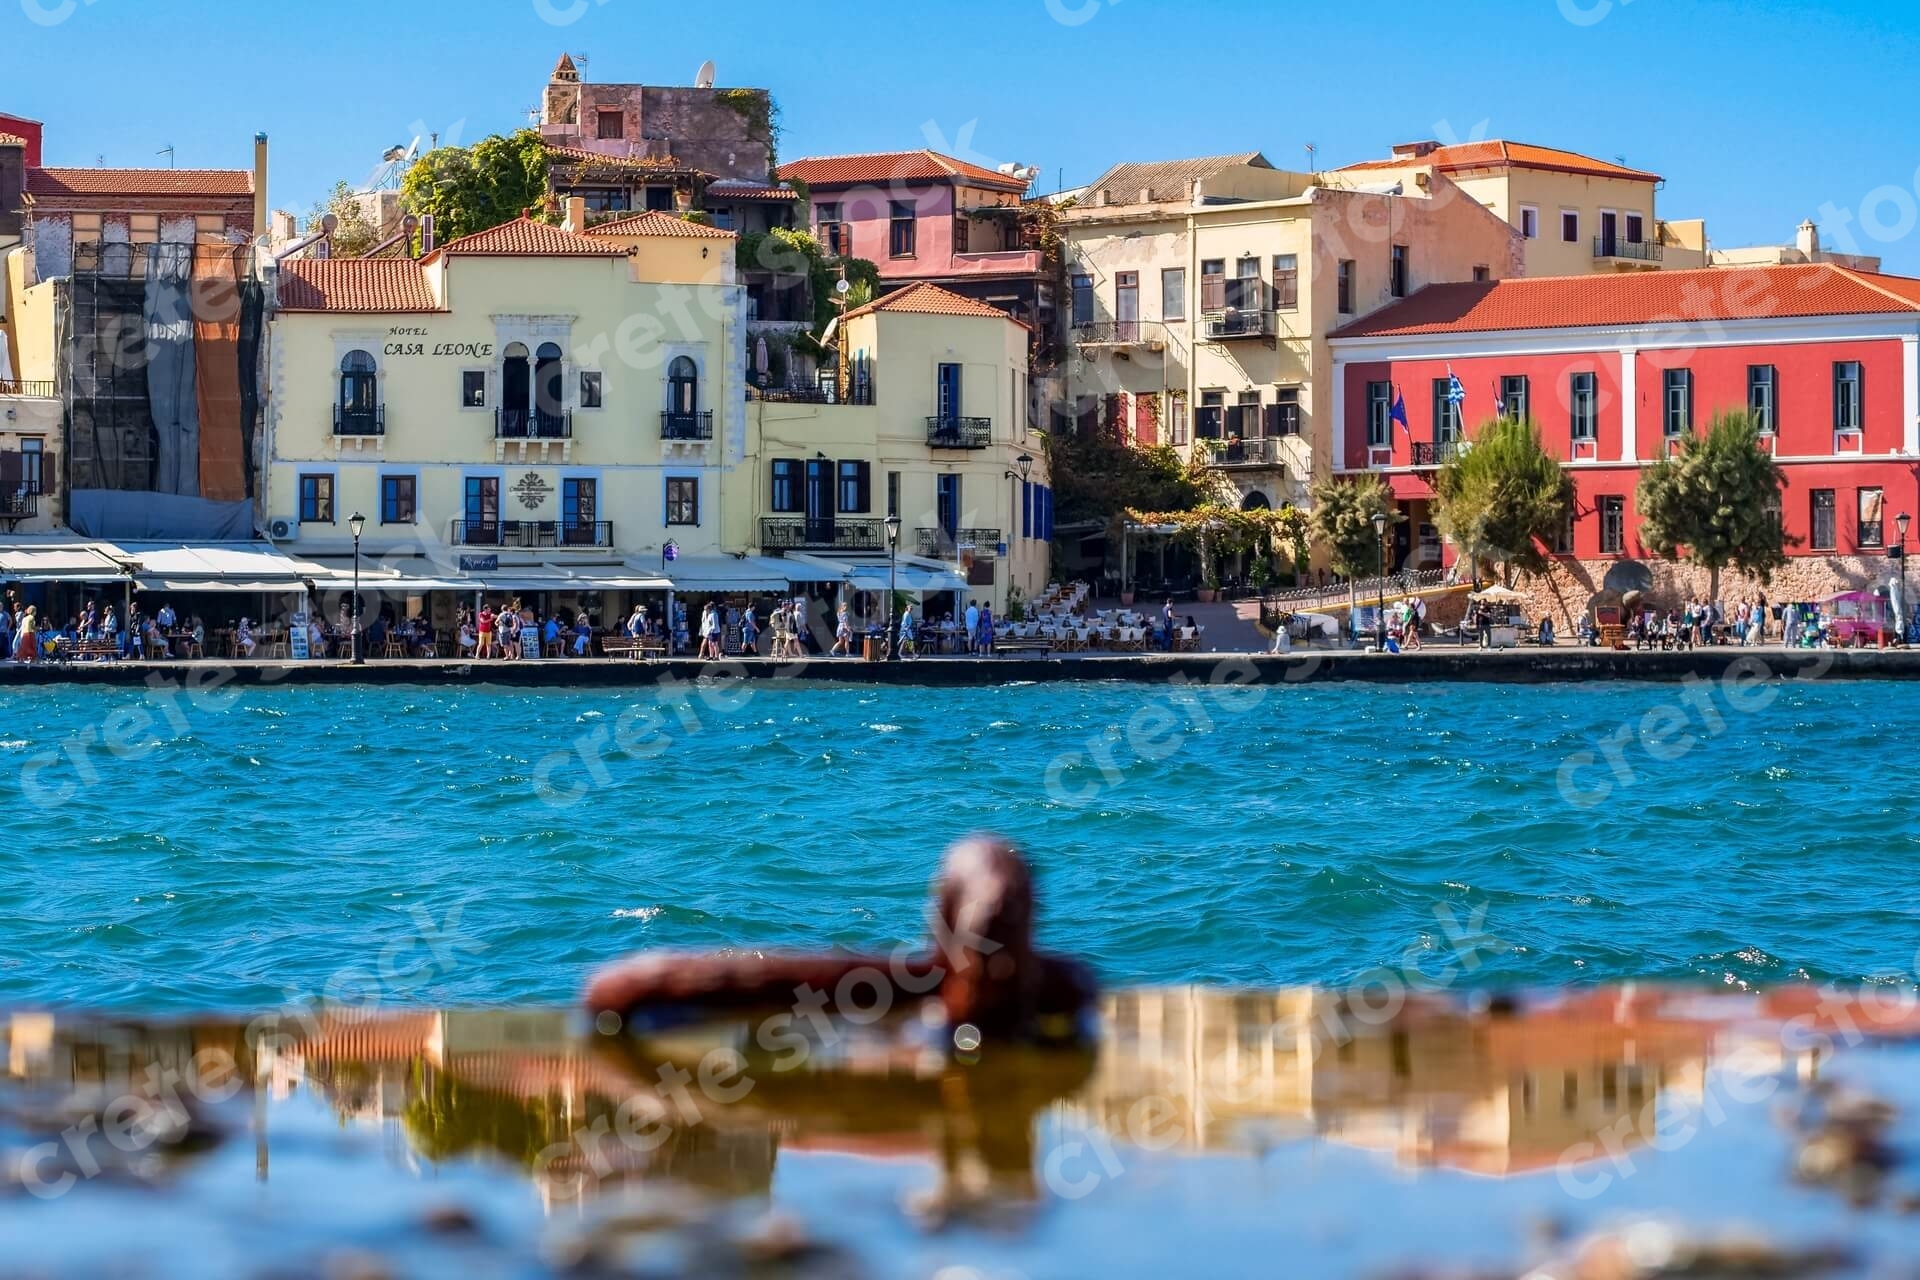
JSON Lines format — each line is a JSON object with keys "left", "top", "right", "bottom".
{"left": 0, "top": 988, "right": 1920, "bottom": 1280}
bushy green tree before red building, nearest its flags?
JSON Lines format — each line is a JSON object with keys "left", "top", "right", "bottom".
{"left": 1434, "top": 418, "right": 1572, "bottom": 585}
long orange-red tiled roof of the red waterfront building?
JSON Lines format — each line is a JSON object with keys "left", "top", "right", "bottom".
{"left": 1332, "top": 263, "right": 1920, "bottom": 338}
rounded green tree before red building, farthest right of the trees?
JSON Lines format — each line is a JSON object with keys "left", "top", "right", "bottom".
{"left": 1636, "top": 409, "right": 1788, "bottom": 597}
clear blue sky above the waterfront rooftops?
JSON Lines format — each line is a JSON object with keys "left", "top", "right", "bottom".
{"left": 11, "top": 0, "right": 1920, "bottom": 273}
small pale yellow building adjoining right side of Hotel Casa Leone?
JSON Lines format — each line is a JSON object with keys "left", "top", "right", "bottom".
{"left": 748, "top": 284, "right": 1052, "bottom": 616}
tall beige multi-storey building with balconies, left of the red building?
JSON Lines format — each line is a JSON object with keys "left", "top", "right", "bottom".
{"left": 1060, "top": 152, "right": 1523, "bottom": 507}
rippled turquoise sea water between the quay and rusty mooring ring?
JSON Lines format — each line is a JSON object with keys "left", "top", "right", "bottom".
{"left": 0, "top": 681, "right": 1920, "bottom": 1009}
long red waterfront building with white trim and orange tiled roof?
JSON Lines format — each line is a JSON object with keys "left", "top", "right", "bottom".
{"left": 1331, "top": 265, "right": 1920, "bottom": 599}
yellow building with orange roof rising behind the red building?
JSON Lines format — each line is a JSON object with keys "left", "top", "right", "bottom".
{"left": 1327, "top": 140, "right": 1707, "bottom": 276}
